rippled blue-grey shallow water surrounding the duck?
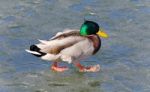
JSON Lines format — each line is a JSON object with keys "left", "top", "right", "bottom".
{"left": 0, "top": 0, "right": 150, "bottom": 92}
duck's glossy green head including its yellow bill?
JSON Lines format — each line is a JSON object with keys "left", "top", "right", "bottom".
{"left": 80, "top": 21, "right": 108, "bottom": 38}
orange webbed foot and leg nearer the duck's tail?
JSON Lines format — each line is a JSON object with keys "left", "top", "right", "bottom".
{"left": 51, "top": 62, "right": 68, "bottom": 72}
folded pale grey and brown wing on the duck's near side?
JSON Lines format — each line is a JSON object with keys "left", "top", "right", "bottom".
{"left": 36, "top": 31, "right": 85, "bottom": 54}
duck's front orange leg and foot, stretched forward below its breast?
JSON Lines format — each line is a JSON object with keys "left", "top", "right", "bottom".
{"left": 74, "top": 62, "right": 100, "bottom": 72}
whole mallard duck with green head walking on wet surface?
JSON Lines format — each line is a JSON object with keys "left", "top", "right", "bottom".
{"left": 26, "top": 21, "right": 108, "bottom": 72}
